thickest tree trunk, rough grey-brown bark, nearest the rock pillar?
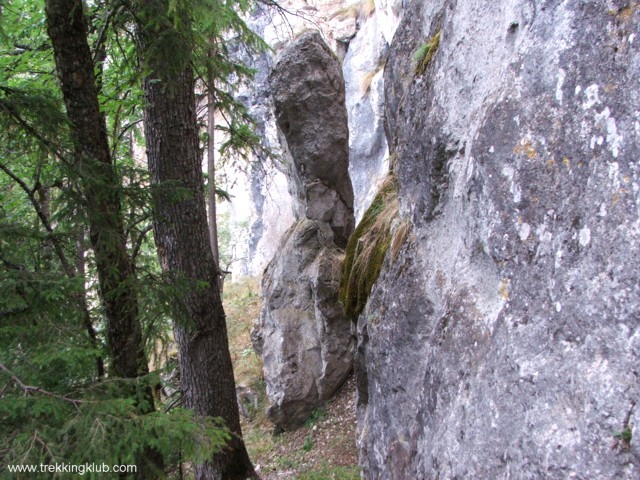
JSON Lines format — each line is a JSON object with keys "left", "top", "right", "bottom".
{"left": 138, "top": 0, "right": 255, "bottom": 480}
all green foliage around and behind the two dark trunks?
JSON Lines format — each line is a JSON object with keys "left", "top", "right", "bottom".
{"left": 0, "top": 0, "right": 264, "bottom": 478}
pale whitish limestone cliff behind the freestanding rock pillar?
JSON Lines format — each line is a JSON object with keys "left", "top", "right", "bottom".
{"left": 220, "top": 0, "right": 402, "bottom": 272}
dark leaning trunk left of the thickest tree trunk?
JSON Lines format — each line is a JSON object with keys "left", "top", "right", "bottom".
{"left": 46, "top": 0, "right": 162, "bottom": 472}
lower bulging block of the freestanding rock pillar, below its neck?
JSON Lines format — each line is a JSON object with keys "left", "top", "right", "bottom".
{"left": 253, "top": 219, "right": 353, "bottom": 428}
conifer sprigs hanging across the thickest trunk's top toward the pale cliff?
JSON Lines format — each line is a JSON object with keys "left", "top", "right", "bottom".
{"left": 139, "top": 0, "right": 271, "bottom": 165}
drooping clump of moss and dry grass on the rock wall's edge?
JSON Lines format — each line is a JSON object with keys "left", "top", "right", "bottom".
{"left": 340, "top": 173, "right": 406, "bottom": 319}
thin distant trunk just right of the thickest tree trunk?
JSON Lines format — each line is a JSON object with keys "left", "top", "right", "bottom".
{"left": 207, "top": 85, "right": 224, "bottom": 295}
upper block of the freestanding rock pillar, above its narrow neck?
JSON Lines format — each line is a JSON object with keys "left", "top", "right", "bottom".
{"left": 269, "top": 32, "right": 354, "bottom": 247}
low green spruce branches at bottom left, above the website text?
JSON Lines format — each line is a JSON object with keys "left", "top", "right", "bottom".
{"left": 0, "top": 372, "right": 230, "bottom": 478}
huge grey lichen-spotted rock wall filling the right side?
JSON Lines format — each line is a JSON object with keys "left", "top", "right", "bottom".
{"left": 357, "top": 0, "right": 640, "bottom": 479}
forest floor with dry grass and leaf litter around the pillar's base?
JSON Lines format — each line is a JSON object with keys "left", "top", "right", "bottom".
{"left": 224, "top": 279, "right": 360, "bottom": 480}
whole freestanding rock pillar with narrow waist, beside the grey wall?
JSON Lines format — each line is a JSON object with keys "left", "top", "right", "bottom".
{"left": 253, "top": 32, "right": 354, "bottom": 428}
